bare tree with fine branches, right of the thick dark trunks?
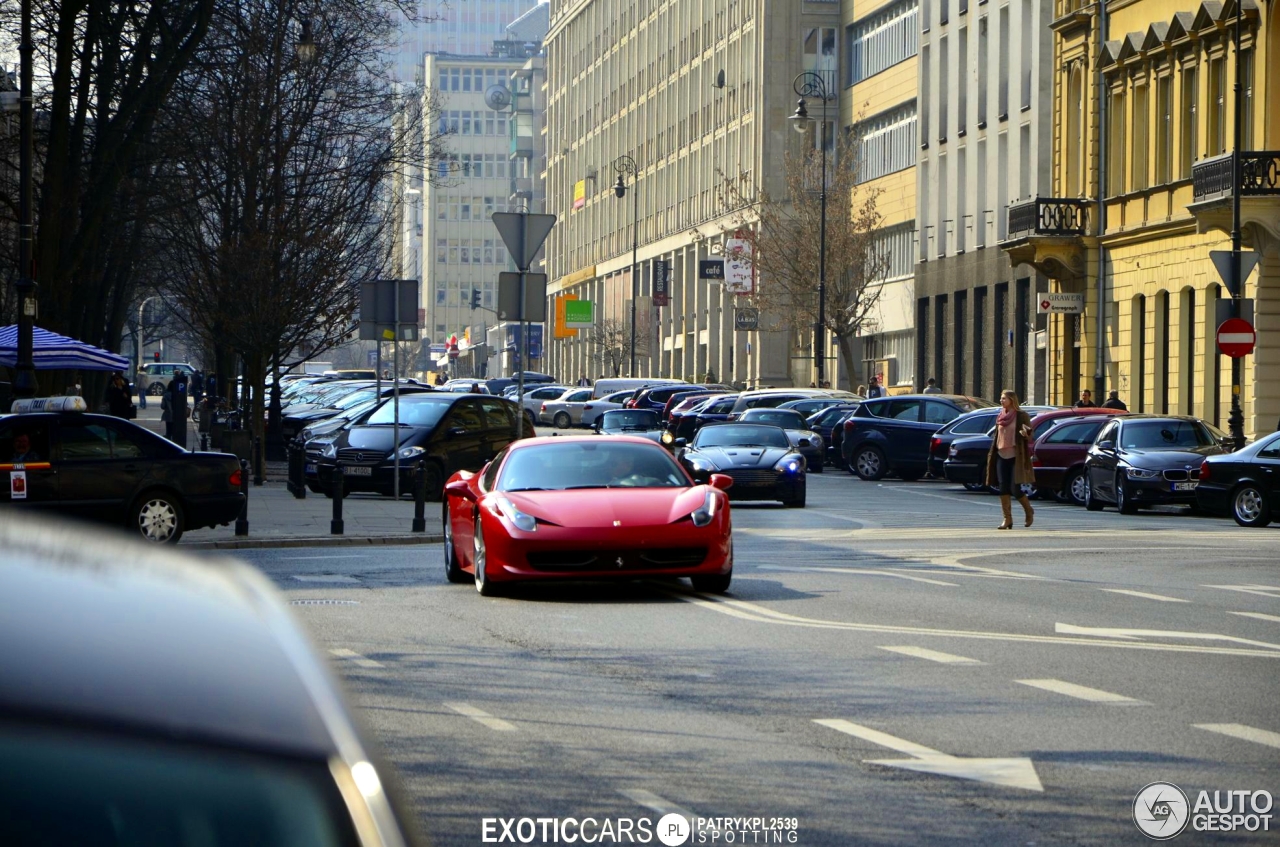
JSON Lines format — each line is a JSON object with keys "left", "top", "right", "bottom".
{"left": 152, "top": 0, "right": 435, "bottom": 458}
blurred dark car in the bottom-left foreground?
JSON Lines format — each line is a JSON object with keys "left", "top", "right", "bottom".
{"left": 0, "top": 521, "right": 416, "bottom": 847}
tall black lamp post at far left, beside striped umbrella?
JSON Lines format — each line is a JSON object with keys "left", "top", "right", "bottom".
{"left": 13, "top": 0, "right": 36, "bottom": 398}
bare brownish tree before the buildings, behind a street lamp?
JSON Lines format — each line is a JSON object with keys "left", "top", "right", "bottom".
{"left": 721, "top": 138, "right": 888, "bottom": 388}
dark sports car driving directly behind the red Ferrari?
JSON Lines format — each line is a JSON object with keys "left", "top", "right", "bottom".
{"left": 676, "top": 422, "right": 806, "bottom": 508}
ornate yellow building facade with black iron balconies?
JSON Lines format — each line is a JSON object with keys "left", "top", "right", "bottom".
{"left": 1004, "top": 0, "right": 1280, "bottom": 439}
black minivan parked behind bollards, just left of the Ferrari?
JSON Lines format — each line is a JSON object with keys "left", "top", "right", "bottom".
{"left": 316, "top": 392, "right": 534, "bottom": 500}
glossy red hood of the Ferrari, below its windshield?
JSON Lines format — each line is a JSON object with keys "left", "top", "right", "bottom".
{"left": 502, "top": 485, "right": 707, "bottom": 528}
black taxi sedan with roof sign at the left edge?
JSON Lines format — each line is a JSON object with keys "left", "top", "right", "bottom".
{"left": 0, "top": 398, "right": 244, "bottom": 542}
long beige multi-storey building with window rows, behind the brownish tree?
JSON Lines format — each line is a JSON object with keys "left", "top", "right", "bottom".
{"left": 544, "top": 0, "right": 840, "bottom": 385}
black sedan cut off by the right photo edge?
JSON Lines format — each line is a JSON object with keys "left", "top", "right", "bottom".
{"left": 1196, "top": 432, "right": 1280, "bottom": 526}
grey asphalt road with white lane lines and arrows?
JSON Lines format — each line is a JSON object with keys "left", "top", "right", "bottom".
{"left": 222, "top": 468, "right": 1280, "bottom": 847}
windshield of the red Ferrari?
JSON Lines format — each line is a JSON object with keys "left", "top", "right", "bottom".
{"left": 498, "top": 439, "right": 690, "bottom": 491}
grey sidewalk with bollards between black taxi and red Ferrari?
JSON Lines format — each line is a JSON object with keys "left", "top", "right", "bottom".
{"left": 136, "top": 398, "right": 443, "bottom": 549}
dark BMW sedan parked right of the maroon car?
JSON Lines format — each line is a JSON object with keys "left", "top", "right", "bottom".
{"left": 1084, "top": 415, "right": 1226, "bottom": 514}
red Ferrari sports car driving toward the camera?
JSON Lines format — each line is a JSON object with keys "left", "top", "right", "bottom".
{"left": 444, "top": 435, "right": 733, "bottom": 596}
